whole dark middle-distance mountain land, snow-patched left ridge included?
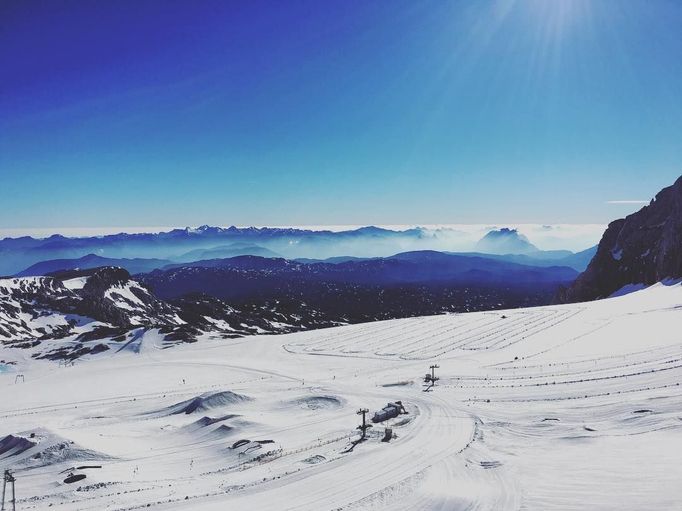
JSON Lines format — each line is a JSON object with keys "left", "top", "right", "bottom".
{"left": 0, "top": 251, "right": 577, "bottom": 358}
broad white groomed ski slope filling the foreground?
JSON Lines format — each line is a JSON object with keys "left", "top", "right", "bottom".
{"left": 0, "top": 283, "right": 682, "bottom": 511}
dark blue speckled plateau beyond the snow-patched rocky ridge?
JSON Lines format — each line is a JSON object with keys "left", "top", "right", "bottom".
{"left": 136, "top": 251, "right": 577, "bottom": 326}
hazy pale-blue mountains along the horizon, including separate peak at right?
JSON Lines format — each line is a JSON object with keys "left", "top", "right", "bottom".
{"left": 0, "top": 226, "right": 596, "bottom": 275}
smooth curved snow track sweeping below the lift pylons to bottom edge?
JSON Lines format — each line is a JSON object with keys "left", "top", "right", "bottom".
{"left": 162, "top": 394, "right": 475, "bottom": 511}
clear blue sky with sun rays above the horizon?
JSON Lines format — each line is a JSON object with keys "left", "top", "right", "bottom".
{"left": 0, "top": 0, "right": 682, "bottom": 229}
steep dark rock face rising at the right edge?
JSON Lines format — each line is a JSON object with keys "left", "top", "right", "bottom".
{"left": 558, "top": 177, "right": 682, "bottom": 302}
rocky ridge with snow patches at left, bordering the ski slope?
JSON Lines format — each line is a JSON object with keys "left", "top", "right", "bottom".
{"left": 0, "top": 267, "right": 328, "bottom": 358}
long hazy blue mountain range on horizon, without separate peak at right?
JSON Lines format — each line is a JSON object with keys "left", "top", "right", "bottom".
{"left": 0, "top": 225, "right": 434, "bottom": 275}
